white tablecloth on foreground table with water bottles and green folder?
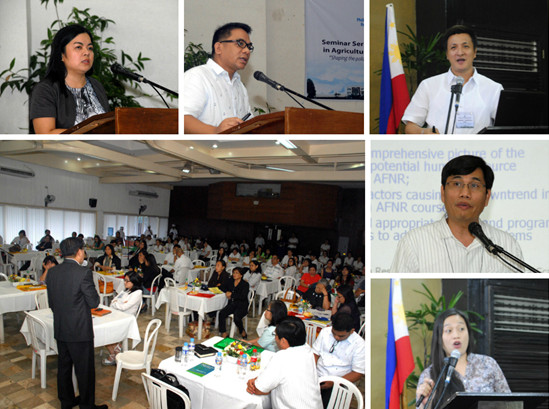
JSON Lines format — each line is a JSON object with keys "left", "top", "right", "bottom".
{"left": 159, "top": 337, "right": 274, "bottom": 409}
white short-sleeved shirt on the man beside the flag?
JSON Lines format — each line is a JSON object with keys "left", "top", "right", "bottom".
{"left": 402, "top": 68, "right": 503, "bottom": 134}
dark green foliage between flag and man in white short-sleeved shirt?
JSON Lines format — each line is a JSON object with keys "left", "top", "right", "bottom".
{"left": 399, "top": 25, "right": 448, "bottom": 95}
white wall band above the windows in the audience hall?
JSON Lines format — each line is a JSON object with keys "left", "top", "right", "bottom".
{"left": 0, "top": 158, "right": 170, "bottom": 232}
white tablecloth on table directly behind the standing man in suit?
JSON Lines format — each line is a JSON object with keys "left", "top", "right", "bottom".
{"left": 21, "top": 305, "right": 141, "bottom": 351}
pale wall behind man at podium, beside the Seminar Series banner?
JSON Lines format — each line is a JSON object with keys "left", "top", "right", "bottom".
{"left": 185, "top": 0, "right": 364, "bottom": 112}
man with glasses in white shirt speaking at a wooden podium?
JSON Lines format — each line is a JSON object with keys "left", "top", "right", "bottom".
{"left": 183, "top": 23, "right": 254, "bottom": 134}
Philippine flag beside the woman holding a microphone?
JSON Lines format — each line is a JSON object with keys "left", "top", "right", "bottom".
{"left": 385, "top": 279, "right": 415, "bottom": 409}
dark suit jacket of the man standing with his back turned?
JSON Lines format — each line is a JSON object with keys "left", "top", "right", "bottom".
{"left": 46, "top": 259, "right": 99, "bottom": 342}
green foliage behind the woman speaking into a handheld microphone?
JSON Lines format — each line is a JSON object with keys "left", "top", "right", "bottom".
{"left": 406, "top": 283, "right": 484, "bottom": 406}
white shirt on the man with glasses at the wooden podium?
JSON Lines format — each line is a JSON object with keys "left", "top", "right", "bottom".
{"left": 183, "top": 59, "right": 253, "bottom": 126}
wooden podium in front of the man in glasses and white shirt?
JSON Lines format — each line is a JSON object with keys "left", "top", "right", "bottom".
{"left": 221, "top": 107, "right": 364, "bottom": 134}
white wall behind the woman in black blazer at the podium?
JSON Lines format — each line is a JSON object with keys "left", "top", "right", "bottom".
{"left": 0, "top": 0, "right": 178, "bottom": 134}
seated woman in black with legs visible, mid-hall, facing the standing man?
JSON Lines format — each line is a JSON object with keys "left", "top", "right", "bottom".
{"left": 219, "top": 267, "right": 250, "bottom": 339}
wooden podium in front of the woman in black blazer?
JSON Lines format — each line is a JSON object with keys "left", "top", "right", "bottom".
{"left": 63, "top": 108, "right": 179, "bottom": 134}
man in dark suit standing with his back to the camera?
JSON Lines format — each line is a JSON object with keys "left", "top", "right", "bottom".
{"left": 46, "top": 237, "right": 107, "bottom": 409}
